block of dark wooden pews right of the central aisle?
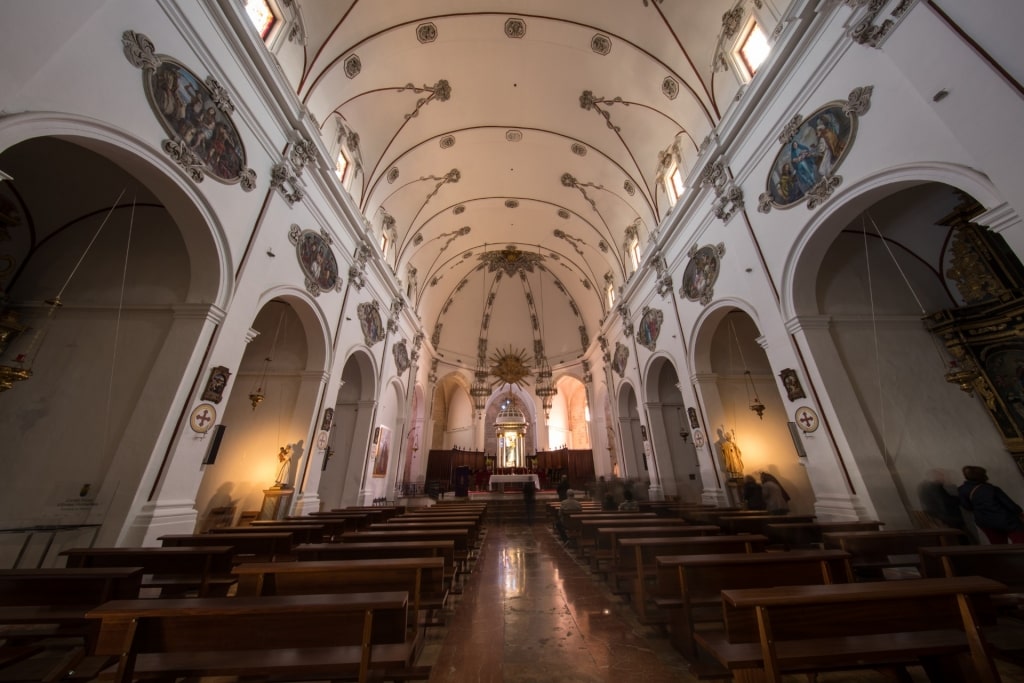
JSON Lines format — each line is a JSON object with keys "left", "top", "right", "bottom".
{"left": 548, "top": 511, "right": 1024, "bottom": 681}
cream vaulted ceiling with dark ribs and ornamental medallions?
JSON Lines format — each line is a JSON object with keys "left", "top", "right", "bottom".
{"left": 289, "top": 0, "right": 770, "bottom": 367}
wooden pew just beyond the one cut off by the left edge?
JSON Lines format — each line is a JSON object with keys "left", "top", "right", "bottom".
{"left": 60, "top": 546, "right": 234, "bottom": 597}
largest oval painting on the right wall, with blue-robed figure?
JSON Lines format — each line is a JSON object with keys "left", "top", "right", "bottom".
{"left": 758, "top": 85, "right": 873, "bottom": 213}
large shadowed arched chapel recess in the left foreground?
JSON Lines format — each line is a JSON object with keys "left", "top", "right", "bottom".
{"left": 0, "top": 135, "right": 224, "bottom": 545}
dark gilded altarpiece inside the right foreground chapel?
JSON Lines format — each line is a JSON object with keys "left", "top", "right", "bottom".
{"left": 926, "top": 200, "right": 1024, "bottom": 474}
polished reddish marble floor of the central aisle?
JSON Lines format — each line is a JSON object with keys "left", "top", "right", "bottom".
{"left": 421, "top": 520, "right": 1024, "bottom": 683}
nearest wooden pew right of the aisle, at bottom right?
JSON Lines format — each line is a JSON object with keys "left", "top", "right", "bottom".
{"left": 694, "top": 577, "right": 1005, "bottom": 683}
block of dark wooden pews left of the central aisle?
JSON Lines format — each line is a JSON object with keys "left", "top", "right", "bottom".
{"left": 0, "top": 499, "right": 483, "bottom": 681}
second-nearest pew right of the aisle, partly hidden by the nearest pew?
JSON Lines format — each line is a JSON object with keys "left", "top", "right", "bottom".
{"left": 654, "top": 550, "right": 850, "bottom": 661}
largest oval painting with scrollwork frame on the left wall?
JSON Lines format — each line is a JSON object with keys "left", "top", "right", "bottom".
{"left": 121, "top": 31, "right": 256, "bottom": 191}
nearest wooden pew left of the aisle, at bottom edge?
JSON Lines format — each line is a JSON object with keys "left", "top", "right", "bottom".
{"left": 89, "top": 592, "right": 429, "bottom": 683}
